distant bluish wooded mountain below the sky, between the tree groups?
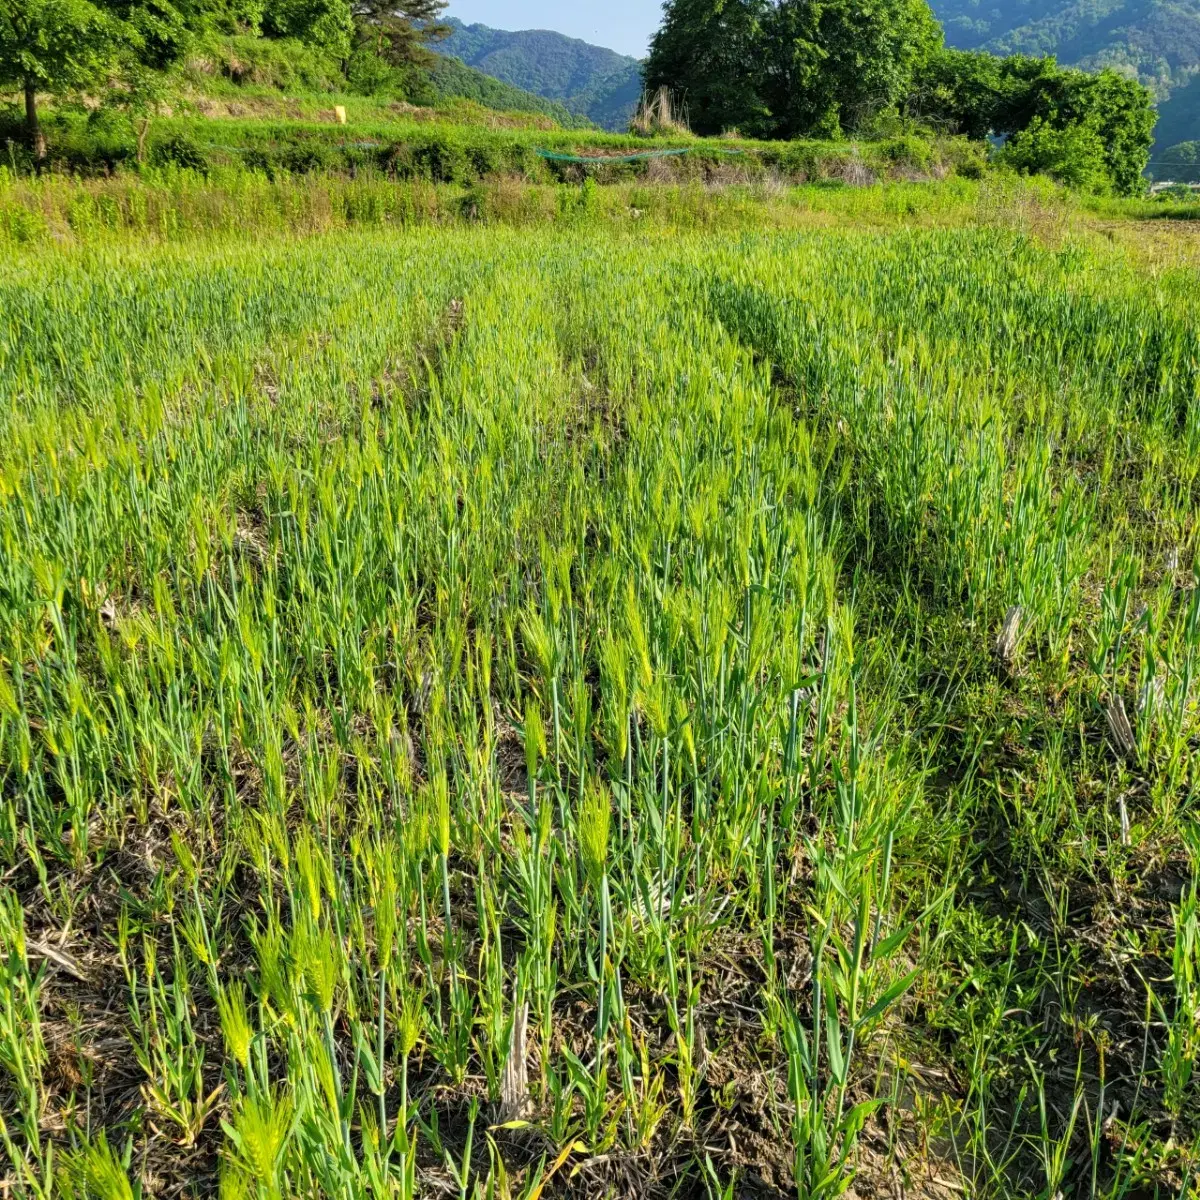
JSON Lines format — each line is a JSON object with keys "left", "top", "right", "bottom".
{"left": 434, "top": 19, "right": 642, "bottom": 128}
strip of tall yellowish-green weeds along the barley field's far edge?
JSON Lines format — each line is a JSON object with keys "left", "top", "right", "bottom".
{"left": 0, "top": 168, "right": 1022, "bottom": 246}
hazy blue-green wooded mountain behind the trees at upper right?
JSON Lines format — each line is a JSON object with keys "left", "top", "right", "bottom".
{"left": 931, "top": 0, "right": 1200, "bottom": 146}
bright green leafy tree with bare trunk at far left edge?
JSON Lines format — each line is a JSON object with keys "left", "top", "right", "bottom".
{"left": 0, "top": 0, "right": 125, "bottom": 163}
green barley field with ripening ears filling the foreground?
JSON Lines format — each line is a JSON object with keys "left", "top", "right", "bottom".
{"left": 0, "top": 223, "right": 1200, "bottom": 1200}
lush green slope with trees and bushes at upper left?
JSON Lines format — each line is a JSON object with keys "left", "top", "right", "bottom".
{"left": 0, "top": 0, "right": 590, "bottom": 169}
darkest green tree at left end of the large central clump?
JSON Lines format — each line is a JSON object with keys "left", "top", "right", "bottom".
{"left": 643, "top": 0, "right": 772, "bottom": 134}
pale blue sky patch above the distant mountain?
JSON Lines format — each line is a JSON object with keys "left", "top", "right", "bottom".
{"left": 448, "top": 0, "right": 662, "bottom": 58}
